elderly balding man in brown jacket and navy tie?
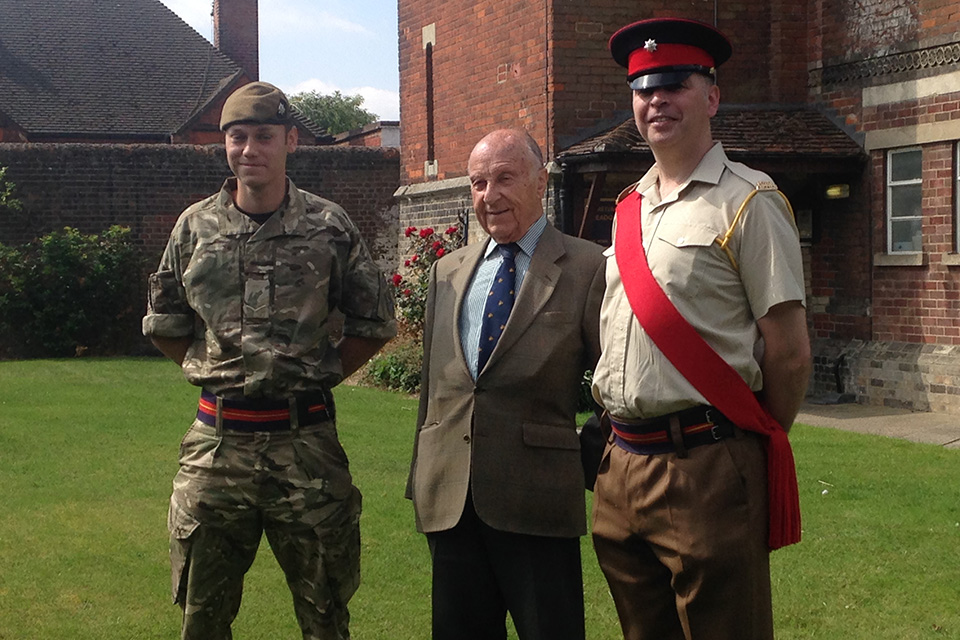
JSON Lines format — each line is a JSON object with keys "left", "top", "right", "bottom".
{"left": 407, "top": 130, "right": 604, "bottom": 640}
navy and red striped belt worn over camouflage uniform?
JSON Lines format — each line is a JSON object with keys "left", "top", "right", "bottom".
{"left": 197, "top": 389, "right": 336, "bottom": 431}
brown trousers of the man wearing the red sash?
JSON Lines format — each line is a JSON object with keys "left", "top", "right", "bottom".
{"left": 593, "top": 432, "right": 773, "bottom": 640}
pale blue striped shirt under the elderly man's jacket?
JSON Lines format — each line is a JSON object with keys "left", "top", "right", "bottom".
{"left": 460, "top": 215, "right": 547, "bottom": 380}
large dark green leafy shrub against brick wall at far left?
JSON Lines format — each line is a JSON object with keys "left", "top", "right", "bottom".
{"left": 0, "top": 226, "right": 142, "bottom": 357}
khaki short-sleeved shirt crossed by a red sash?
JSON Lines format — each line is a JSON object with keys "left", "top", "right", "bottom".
{"left": 593, "top": 143, "right": 804, "bottom": 418}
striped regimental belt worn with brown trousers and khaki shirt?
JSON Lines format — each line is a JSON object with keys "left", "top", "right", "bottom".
{"left": 610, "top": 406, "right": 736, "bottom": 455}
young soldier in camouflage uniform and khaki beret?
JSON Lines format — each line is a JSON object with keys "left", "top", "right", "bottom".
{"left": 143, "top": 82, "right": 396, "bottom": 640}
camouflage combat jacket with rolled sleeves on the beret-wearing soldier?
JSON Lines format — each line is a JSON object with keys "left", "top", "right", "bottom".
{"left": 143, "top": 178, "right": 397, "bottom": 398}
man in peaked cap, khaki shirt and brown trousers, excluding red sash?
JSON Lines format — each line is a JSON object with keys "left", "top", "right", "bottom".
{"left": 593, "top": 18, "right": 810, "bottom": 640}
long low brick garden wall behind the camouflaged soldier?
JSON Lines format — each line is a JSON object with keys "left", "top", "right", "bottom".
{"left": 0, "top": 144, "right": 399, "bottom": 271}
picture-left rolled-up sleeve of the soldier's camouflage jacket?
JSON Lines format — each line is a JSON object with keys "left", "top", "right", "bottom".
{"left": 142, "top": 224, "right": 194, "bottom": 338}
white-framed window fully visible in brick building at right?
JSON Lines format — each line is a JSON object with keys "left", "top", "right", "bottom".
{"left": 887, "top": 147, "right": 923, "bottom": 253}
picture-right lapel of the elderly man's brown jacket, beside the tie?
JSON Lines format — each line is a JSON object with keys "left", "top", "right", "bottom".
{"left": 487, "top": 224, "right": 565, "bottom": 367}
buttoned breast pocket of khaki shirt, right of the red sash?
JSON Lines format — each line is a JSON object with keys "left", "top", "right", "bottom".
{"left": 650, "top": 221, "right": 723, "bottom": 296}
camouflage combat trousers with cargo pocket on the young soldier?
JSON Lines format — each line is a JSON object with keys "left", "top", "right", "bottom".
{"left": 168, "top": 421, "right": 360, "bottom": 640}
